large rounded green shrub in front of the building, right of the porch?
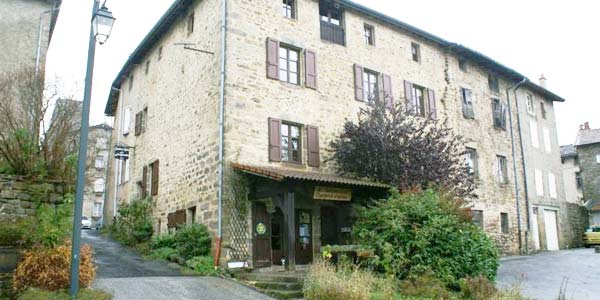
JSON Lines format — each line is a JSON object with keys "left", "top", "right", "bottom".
{"left": 353, "top": 190, "right": 498, "bottom": 288}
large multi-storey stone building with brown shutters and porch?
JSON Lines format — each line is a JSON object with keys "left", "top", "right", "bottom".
{"left": 105, "top": 0, "right": 564, "bottom": 267}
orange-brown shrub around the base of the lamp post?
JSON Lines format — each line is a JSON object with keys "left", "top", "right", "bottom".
{"left": 13, "top": 243, "right": 96, "bottom": 292}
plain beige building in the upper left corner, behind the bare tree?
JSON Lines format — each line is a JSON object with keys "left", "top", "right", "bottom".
{"left": 0, "top": 0, "right": 62, "bottom": 72}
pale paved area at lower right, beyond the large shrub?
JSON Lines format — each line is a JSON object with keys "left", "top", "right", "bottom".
{"left": 497, "top": 249, "right": 600, "bottom": 300}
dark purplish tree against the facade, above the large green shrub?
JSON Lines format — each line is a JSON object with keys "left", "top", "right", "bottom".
{"left": 330, "top": 101, "right": 475, "bottom": 199}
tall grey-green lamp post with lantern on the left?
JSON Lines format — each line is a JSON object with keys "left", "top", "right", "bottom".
{"left": 70, "top": 0, "right": 115, "bottom": 299}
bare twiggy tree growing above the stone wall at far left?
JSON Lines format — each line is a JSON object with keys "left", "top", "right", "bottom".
{"left": 0, "top": 67, "right": 80, "bottom": 179}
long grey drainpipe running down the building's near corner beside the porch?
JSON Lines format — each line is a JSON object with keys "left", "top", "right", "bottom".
{"left": 215, "top": 0, "right": 227, "bottom": 266}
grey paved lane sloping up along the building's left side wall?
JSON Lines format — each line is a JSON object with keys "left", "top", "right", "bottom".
{"left": 82, "top": 230, "right": 272, "bottom": 300}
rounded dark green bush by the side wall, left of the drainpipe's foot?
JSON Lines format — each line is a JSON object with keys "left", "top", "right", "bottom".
{"left": 175, "top": 224, "right": 211, "bottom": 260}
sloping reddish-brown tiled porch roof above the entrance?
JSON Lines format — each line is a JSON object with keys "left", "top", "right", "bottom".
{"left": 230, "top": 163, "right": 391, "bottom": 189}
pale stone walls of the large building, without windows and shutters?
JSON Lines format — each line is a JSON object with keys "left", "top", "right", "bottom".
{"left": 105, "top": 0, "right": 564, "bottom": 260}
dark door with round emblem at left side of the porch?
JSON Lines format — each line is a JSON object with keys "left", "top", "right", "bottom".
{"left": 252, "top": 202, "right": 271, "bottom": 267}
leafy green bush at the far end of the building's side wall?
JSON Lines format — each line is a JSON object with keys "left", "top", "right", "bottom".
{"left": 110, "top": 199, "right": 153, "bottom": 246}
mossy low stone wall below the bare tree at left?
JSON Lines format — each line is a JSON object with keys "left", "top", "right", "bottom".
{"left": 0, "top": 175, "right": 72, "bottom": 222}
